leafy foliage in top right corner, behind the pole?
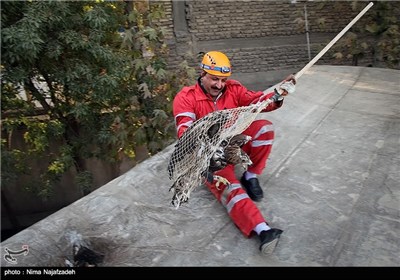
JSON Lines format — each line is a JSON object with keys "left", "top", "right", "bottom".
{"left": 334, "top": 1, "right": 400, "bottom": 69}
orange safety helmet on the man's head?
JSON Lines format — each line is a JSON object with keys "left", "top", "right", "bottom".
{"left": 200, "top": 51, "right": 232, "bottom": 77}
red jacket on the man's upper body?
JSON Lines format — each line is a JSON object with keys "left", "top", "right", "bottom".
{"left": 173, "top": 80, "right": 282, "bottom": 138}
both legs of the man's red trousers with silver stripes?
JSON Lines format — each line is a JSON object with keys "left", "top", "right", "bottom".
{"left": 206, "top": 120, "right": 274, "bottom": 237}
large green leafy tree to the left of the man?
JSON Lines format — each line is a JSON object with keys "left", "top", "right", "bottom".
{"left": 1, "top": 1, "right": 193, "bottom": 196}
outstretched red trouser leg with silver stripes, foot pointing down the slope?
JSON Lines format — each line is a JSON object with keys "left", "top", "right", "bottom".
{"left": 206, "top": 165, "right": 265, "bottom": 236}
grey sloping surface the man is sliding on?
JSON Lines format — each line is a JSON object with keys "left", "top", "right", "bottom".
{"left": 1, "top": 66, "right": 400, "bottom": 267}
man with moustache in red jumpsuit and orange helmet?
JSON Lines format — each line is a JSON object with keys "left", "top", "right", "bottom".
{"left": 173, "top": 51, "right": 296, "bottom": 254}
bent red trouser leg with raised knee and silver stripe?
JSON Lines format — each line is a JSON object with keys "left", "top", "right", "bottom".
{"left": 243, "top": 120, "right": 275, "bottom": 174}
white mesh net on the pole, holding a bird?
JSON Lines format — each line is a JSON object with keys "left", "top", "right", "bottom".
{"left": 168, "top": 99, "right": 272, "bottom": 208}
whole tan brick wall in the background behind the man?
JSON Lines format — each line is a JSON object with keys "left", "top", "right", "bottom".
{"left": 152, "top": 0, "right": 396, "bottom": 77}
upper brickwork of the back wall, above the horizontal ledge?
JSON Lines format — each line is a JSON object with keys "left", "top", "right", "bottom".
{"left": 187, "top": 0, "right": 364, "bottom": 41}
